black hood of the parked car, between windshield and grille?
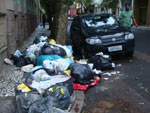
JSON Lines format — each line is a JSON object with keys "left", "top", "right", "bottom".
{"left": 83, "top": 26, "right": 130, "bottom": 38}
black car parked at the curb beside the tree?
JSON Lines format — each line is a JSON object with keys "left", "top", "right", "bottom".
{"left": 70, "top": 13, "right": 135, "bottom": 57}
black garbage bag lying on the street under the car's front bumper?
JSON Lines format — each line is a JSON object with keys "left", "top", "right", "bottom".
{"left": 88, "top": 55, "right": 115, "bottom": 70}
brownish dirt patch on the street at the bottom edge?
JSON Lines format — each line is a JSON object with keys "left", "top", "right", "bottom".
{"left": 86, "top": 99, "right": 142, "bottom": 113}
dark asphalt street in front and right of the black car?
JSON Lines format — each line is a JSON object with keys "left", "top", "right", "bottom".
{"left": 83, "top": 29, "right": 150, "bottom": 113}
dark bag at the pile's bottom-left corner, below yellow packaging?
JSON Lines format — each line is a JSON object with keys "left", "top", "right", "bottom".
{"left": 15, "top": 93, "right": 42, "bottom": 113}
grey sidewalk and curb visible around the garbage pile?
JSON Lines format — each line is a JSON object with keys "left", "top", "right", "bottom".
{"left": 0, "top": 26, "right": 84, "bottom": 113}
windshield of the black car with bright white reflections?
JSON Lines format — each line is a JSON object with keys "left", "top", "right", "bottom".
{"left": 82, "top": 16, "right": 118, "bottom": 27}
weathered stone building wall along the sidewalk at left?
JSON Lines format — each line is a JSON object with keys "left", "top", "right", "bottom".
{"left": 0, "top": 0, "right": 41, "bottom": 68}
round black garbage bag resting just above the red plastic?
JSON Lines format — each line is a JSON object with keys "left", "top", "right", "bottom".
{"left": 69, "top": 63, "right": 94, "bottom": 84}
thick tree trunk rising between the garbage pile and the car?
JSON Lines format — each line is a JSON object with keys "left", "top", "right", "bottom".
{"left": 52, "top": 0, "right": 68, "bottom": 44}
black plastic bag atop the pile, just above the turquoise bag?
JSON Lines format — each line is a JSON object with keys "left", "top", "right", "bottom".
{"left": 41, "top": 44, "right": 66, "bottom": 57}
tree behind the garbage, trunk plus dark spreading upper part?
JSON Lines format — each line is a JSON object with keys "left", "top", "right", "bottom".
{"left": 40, "top": 0, "right": 92, "bottom": 44}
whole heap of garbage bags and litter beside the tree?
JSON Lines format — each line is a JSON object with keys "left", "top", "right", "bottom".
{"left": 4, "top": 34, "right": 115, "bottom": 113}
